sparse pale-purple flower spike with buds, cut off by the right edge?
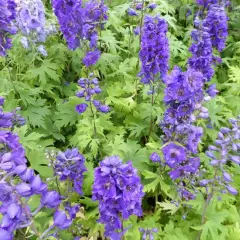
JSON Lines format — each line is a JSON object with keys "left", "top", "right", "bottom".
{"left": 200, "top": 116, "right": 240, "bottom": 195}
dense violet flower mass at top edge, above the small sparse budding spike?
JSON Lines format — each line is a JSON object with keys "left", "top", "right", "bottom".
{"left": 53, "top": 0, "right": 107, "bottom": 67}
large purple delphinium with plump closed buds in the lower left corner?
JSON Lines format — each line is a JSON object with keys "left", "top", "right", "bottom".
{"left": 0, "top": 97, "right": 79, "bottom": 240}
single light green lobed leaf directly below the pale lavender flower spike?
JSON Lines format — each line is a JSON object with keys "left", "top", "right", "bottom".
{"left": 27, "top": 59, "right": 60, "bottom": 86}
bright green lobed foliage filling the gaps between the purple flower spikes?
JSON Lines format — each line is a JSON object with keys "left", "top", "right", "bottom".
{"left": 0, "top": 0, "right": 240, "bottom": 240}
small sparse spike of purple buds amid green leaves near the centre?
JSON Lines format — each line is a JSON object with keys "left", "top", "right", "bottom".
{"left": 76, "top": 73, "right": 110, "bottom": 114}
